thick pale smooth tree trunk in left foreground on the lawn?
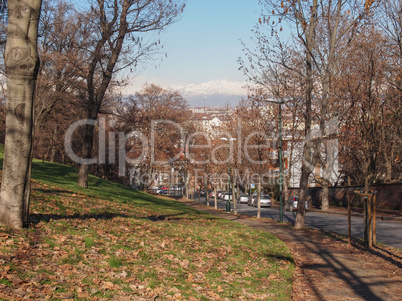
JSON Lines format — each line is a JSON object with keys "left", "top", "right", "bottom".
{"left": 0, "top": 0, "right": 42, "bottom": 228}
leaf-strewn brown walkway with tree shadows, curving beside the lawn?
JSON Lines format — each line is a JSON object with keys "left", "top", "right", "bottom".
{"left": 180, "top": 199, "right": 402, "bottom": 301}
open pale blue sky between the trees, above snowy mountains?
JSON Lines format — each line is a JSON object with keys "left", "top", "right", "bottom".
{"left": 127, "top": 0, "right": 260, "bottom": 88}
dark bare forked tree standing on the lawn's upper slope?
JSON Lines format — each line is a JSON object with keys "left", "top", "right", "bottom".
{"left": 78, "top": 0, "right": 184, "bottom": 187}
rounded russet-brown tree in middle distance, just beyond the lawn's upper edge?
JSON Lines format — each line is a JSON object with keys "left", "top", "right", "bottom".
{"left": 118, "top": 84, "right": 190, "bottom": 188}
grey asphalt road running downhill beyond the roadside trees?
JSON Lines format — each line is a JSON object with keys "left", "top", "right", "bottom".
{"left": 192, "top": 197, "right": 402, "bottom": 249}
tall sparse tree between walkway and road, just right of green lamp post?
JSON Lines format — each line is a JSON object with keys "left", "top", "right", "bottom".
{"left": 239, "top": 0, "right": 371, "bottom": 228}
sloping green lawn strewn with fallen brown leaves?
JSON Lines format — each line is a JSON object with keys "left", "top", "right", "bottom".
{"left": 0, "top": 152, "right": 294, "bottom": 300}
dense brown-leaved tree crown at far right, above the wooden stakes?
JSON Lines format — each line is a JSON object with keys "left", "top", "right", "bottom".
{"left": 338, "top": 28, "right": 402, "bottom": 192}
